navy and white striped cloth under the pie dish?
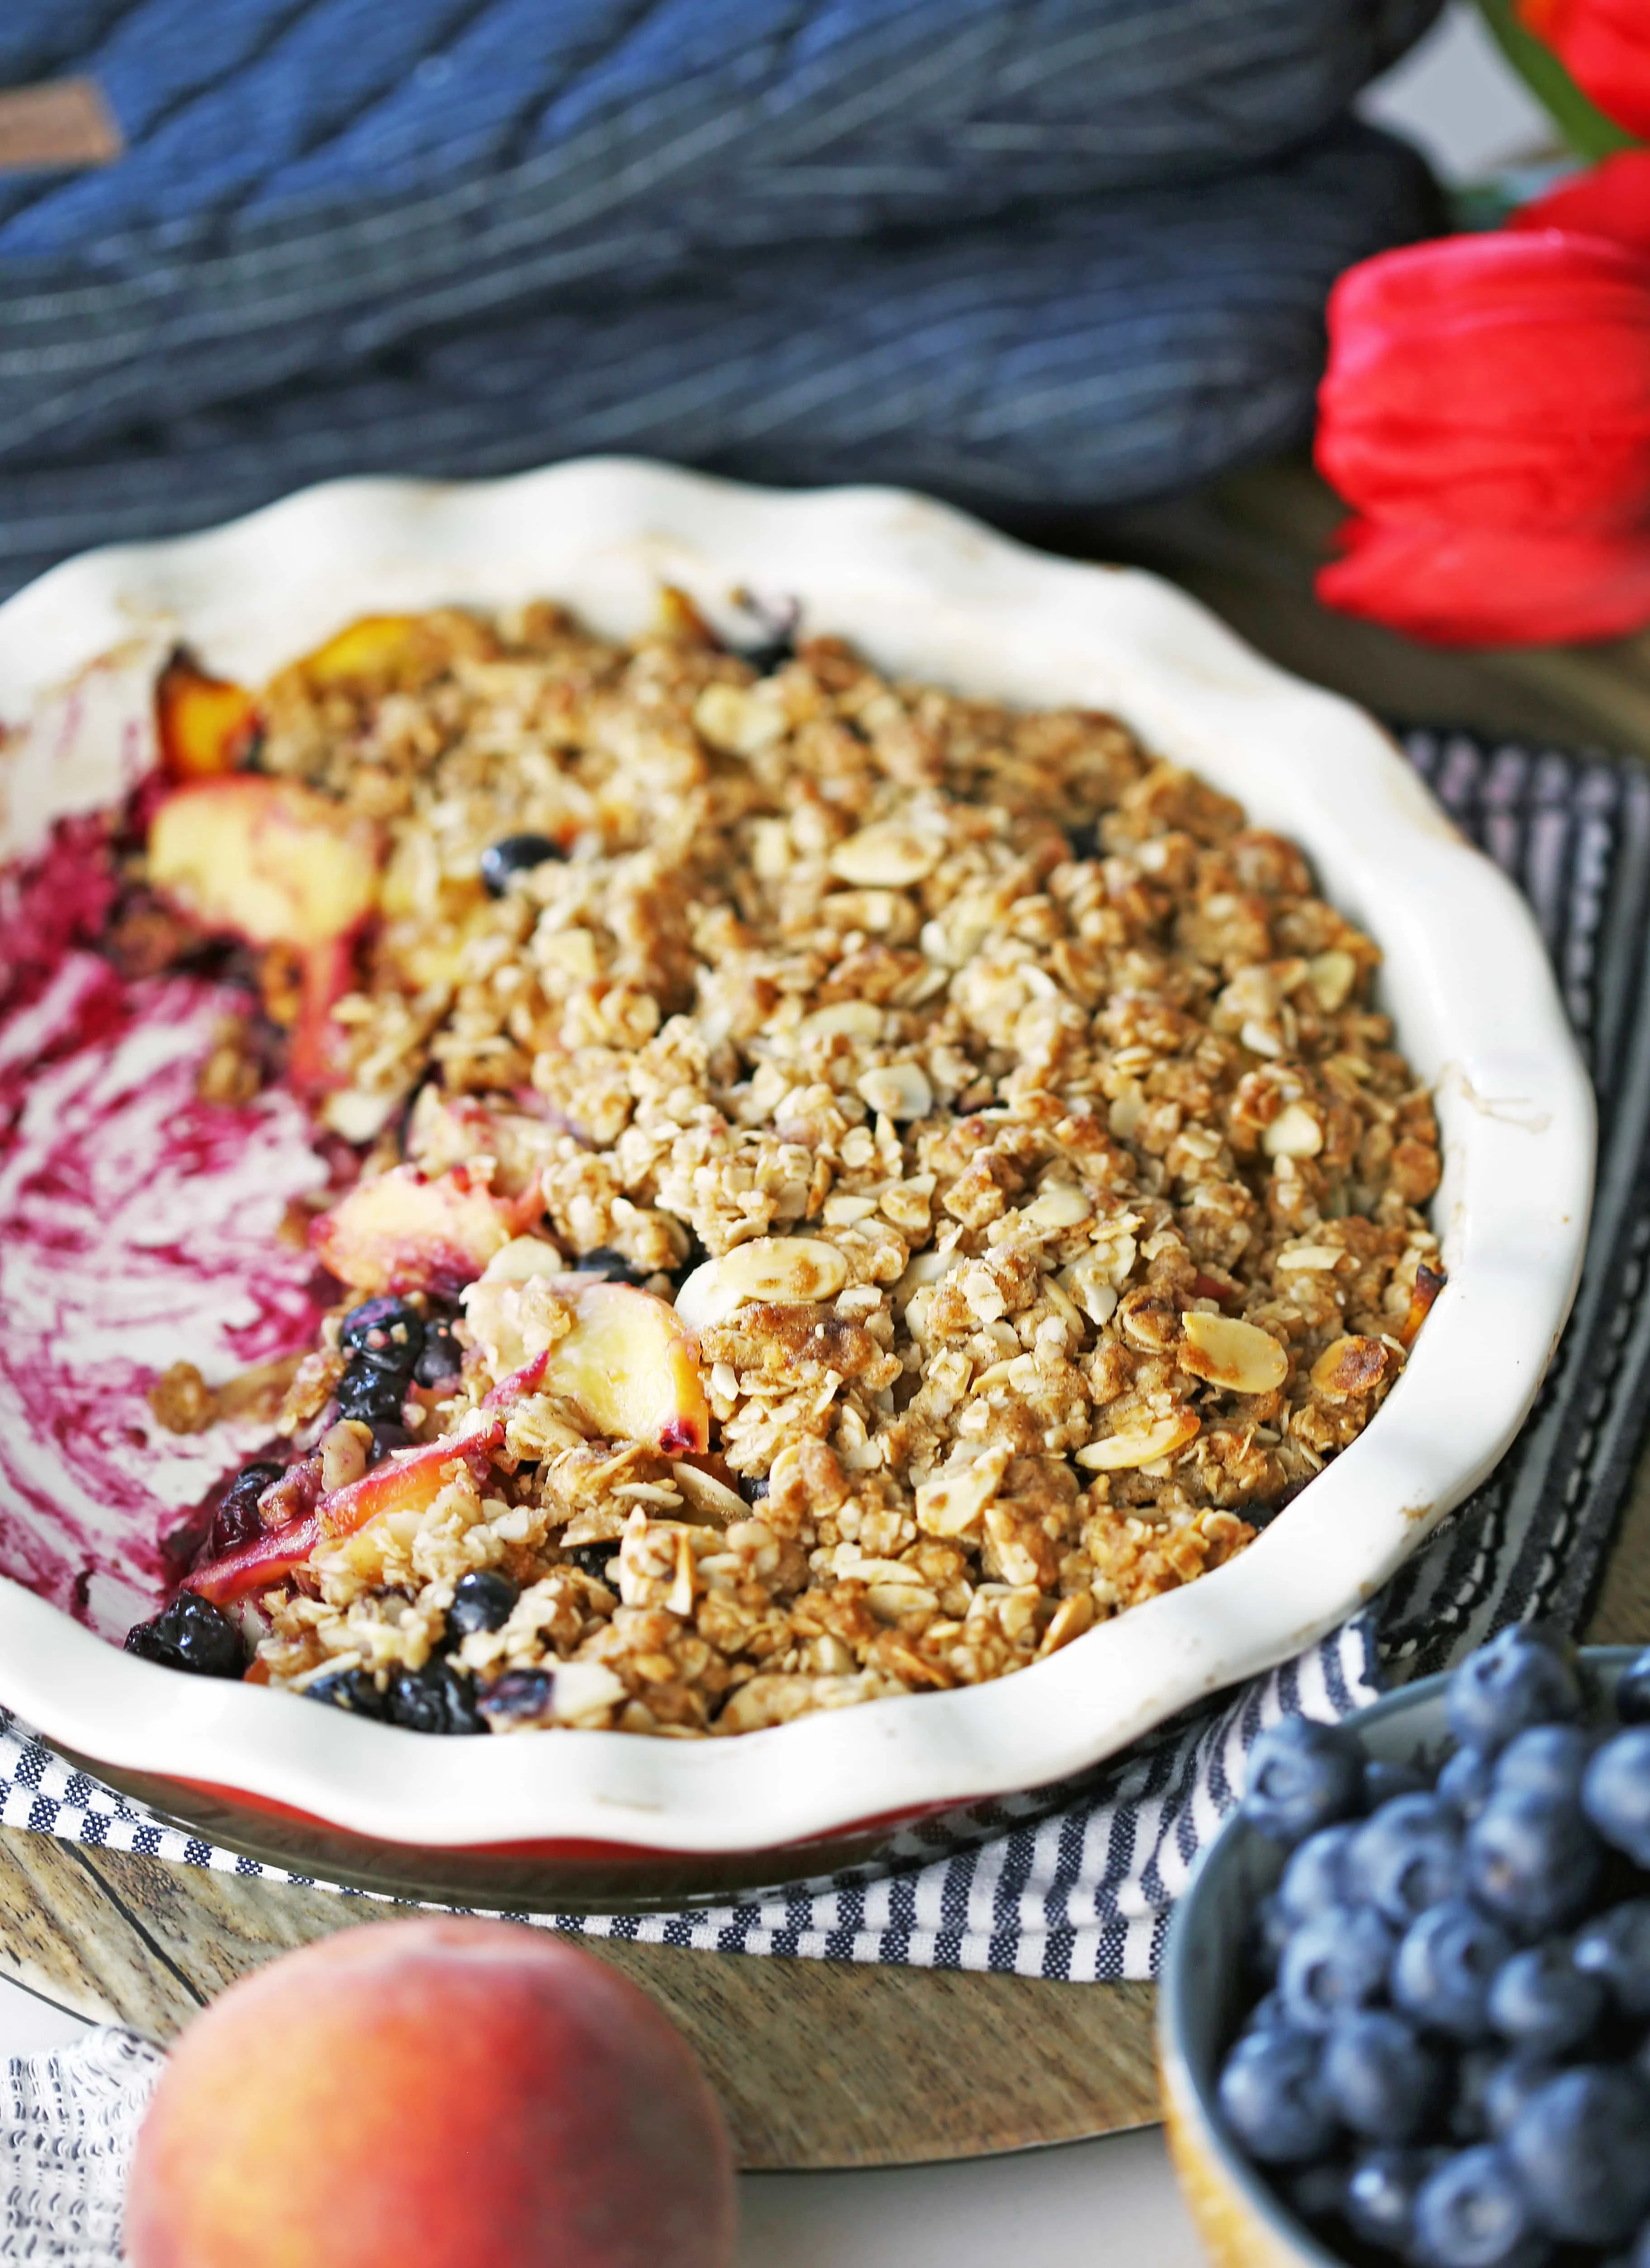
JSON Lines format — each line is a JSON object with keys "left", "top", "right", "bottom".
{"left": 0, "top": 733, "right": 1650, "bottom": 1982}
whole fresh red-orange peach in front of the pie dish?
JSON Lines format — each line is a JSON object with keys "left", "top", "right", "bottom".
{"left": 125, "top": 1917, "right": 735, "bottom": 2268}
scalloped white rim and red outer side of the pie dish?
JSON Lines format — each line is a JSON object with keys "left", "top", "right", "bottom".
{"left": 0, "top": 460, "right": 1593, "bottom": 1903}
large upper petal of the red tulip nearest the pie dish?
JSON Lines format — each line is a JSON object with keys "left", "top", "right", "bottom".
{"left": 1316, "top": 229, "right": 1650, "bottom": 531}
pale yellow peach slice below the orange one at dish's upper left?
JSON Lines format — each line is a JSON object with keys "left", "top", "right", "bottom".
{"left": 150, "top": 776, "right": 379, "bottom": 952}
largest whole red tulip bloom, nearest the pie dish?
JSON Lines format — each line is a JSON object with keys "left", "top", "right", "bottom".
{"left": 1316, "top": 229, "right": 1650, "bottom": 644}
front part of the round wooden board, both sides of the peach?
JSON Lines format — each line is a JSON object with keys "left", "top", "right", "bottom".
{"left": 0, "top": 1828, "right": 1157, "bottom": 2170}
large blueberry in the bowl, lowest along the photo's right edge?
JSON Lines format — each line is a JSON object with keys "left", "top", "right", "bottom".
{"left": 1505, "top": 2064, "right": 1650, "bottom": 2245}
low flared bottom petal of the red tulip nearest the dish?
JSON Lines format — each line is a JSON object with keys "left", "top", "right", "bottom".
{"left": 1316, "top": 519, "right": 1650, "bottom": 646}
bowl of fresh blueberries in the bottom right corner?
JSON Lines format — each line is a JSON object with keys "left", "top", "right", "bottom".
{"left": 1157, "top": 1626, "right": 1650, "bottom": 2268}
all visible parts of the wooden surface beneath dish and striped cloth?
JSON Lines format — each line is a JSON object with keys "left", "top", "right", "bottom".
{"left": 0, "top": 465, "right": 1650, "bottom": 2168}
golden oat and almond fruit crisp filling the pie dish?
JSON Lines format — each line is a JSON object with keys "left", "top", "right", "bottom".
{"left": 104, "top": 594, "right": 1441, "bottom": 1735}
